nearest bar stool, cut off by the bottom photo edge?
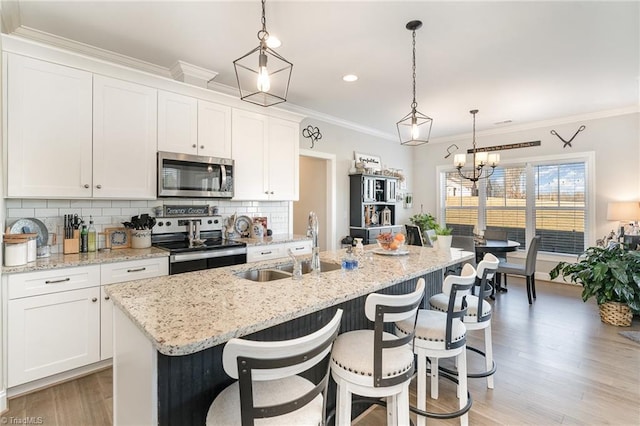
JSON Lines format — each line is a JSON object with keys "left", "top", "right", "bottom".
{"left": 206, "top": 309, "right": 342, "bottom": 426}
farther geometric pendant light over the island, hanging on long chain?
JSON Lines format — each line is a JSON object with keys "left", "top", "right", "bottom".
{"left": 397, "top": 21, "right": 433, "bottom": 146}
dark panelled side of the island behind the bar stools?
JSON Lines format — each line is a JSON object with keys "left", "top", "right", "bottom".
{"left": 157, "top": 270, "right": 442, "bottom": 425}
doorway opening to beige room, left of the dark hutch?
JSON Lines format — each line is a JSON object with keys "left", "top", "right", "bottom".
{"left": 293, "top": 149, "right": 337, "bottom": 251}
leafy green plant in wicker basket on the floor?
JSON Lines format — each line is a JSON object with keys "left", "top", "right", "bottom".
{"left": 549, "top": 245, "right": 640, "bottom": 326}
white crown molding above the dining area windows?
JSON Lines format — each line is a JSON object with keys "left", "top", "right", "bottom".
{"left": 430, "top": 104, "right": 640, "bottom": 144}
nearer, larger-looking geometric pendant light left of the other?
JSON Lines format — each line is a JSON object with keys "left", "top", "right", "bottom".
{"left": 233, "top": 0, "right": 293, "bottom": 107}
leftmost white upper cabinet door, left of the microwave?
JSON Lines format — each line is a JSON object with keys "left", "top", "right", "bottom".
{"left": 5, "top": 55, "right": 92, "bottom": 198}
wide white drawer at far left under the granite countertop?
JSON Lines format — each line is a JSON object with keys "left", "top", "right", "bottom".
{"left": 7, "top": 265, "right": 100, "bottom": 299}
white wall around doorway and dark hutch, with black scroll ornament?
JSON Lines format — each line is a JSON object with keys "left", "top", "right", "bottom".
{"left": 300, "top": 119, "right": 417, "bottom": 241}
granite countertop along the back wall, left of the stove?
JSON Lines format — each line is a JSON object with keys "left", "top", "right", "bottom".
{"left": 2, "top": 247, "right": 169, "bottom": 274}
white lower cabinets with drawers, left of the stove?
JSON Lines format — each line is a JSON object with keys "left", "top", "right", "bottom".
{"left": 2, "top": 257, "right": 169, "bottom": 387}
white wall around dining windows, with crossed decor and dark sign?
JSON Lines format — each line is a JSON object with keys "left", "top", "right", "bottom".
{"left": 413, "top": 112, "right": 640, "bottom": 244}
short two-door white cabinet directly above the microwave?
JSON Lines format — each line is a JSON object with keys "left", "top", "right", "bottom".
{"left": 158, "top": 91, "right": 231, "bottom": 158}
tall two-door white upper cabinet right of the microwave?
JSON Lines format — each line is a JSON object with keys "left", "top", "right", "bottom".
{"left": 232, "top": 109, "right": 299, "bottom": 200}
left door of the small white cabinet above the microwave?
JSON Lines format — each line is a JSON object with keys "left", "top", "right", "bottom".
{"left": 158, "top": 90, "right": 198, "bottom": 155}
